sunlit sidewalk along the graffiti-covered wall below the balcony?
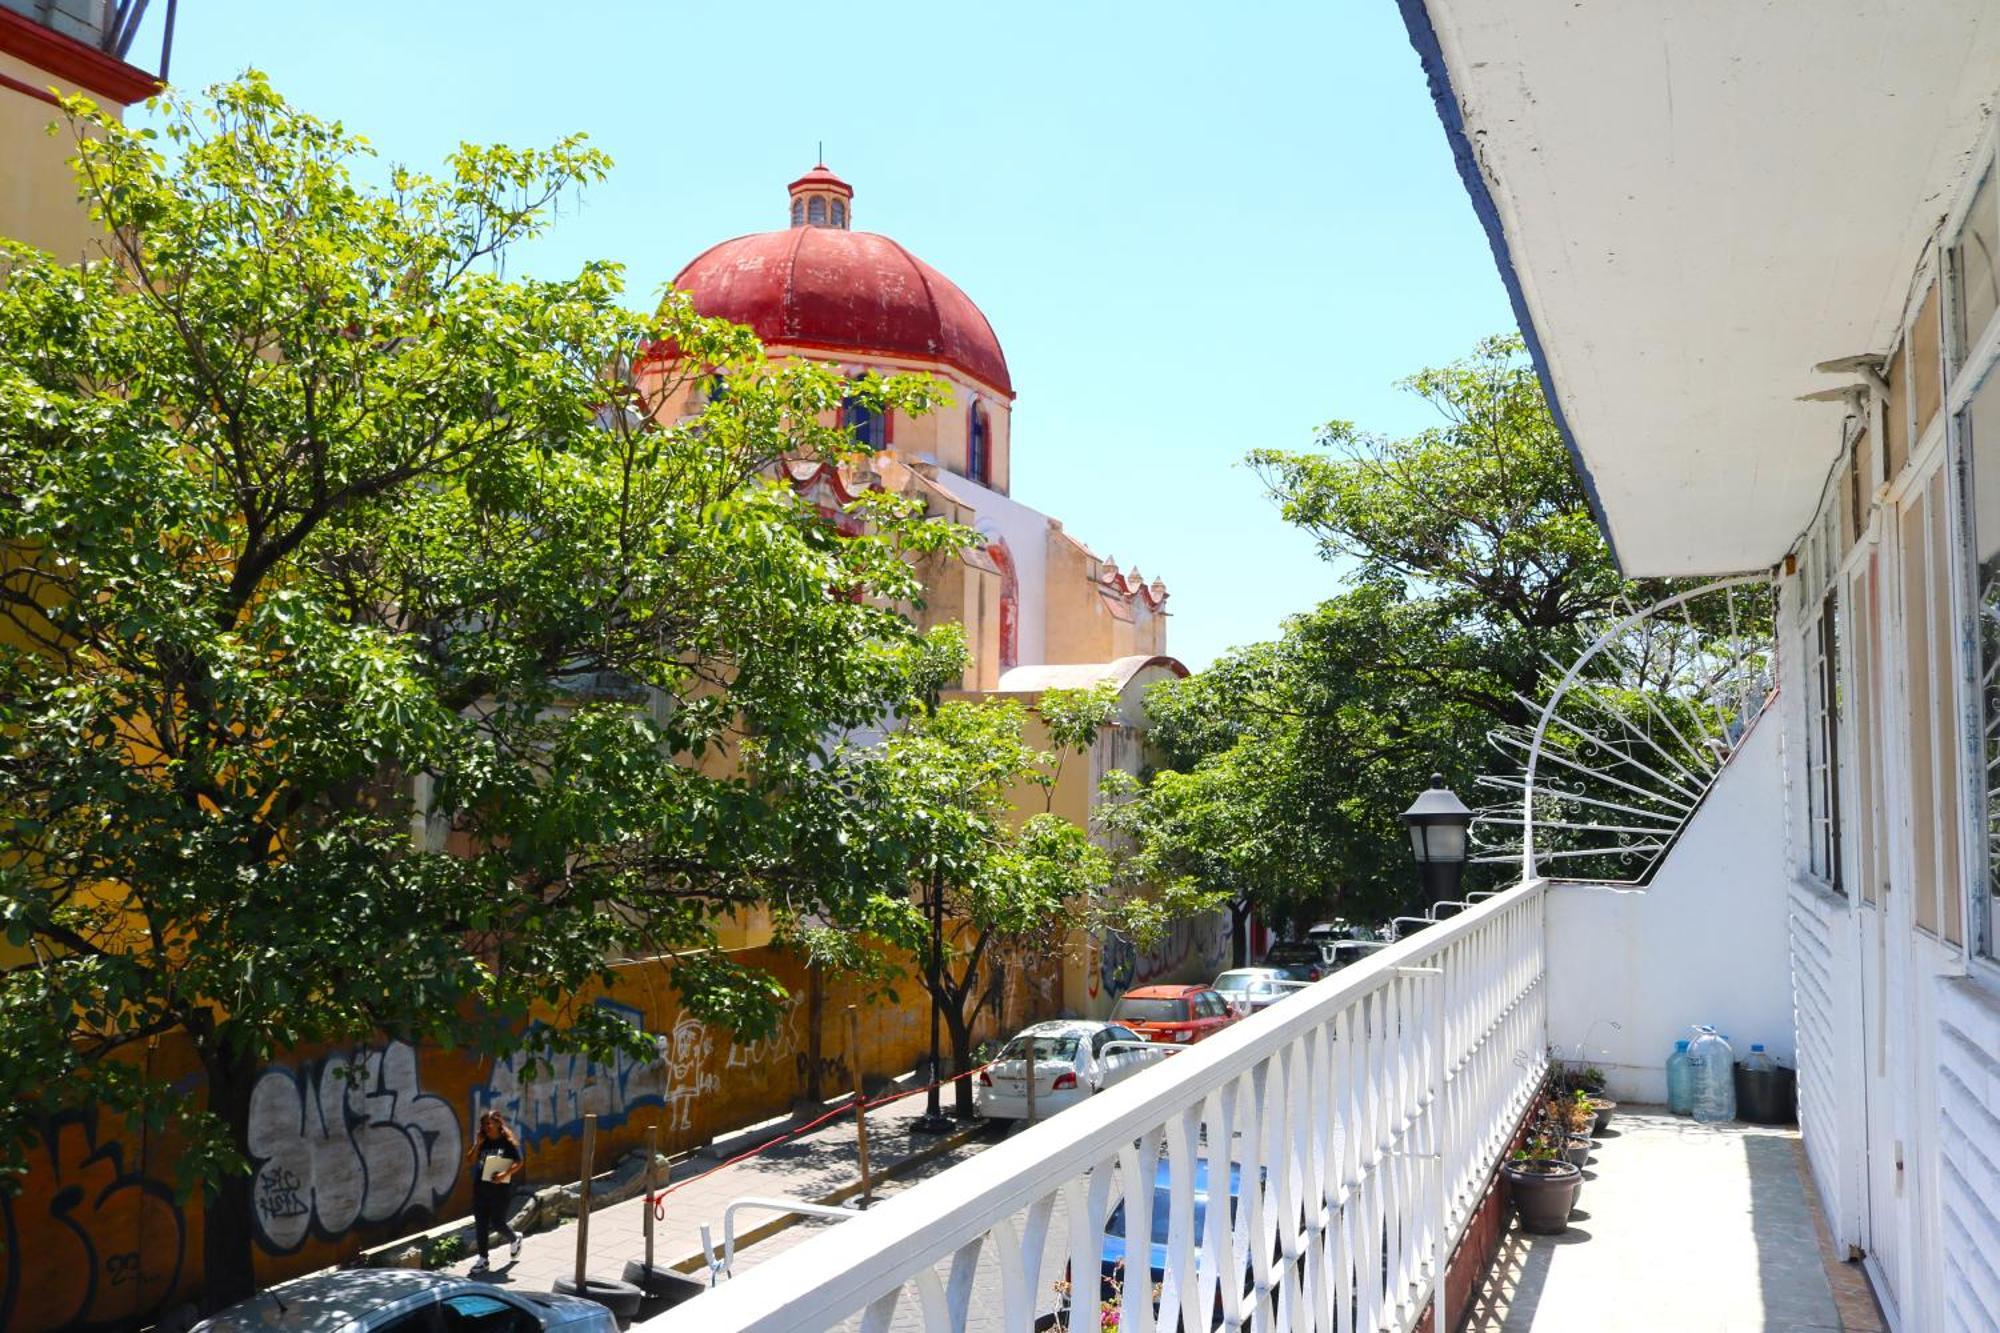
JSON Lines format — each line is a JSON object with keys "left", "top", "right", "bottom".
{"left": 442, "top": 1091, "right": 984, "bottom": 1291}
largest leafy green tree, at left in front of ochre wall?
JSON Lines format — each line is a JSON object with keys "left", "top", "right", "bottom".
{"left": 0, "top": 74, "right": 964, "bottom": 1305}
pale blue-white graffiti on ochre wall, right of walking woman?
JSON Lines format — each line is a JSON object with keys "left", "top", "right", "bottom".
{"left": 472, "top": 999, "right": 680, "bottom": 1143}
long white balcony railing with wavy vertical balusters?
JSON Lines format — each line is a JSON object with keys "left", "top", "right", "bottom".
{"left": 642, "top": 883, "right": 1546, "bottom": 1333}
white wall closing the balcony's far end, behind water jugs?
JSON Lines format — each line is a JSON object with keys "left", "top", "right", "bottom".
{"left": 1548, "top": 717, "right": 1794, "bottom": 1103}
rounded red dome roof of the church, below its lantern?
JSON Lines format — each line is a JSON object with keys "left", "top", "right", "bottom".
{"left": 674, "top": 226, "right": 1014, "bottom": 398}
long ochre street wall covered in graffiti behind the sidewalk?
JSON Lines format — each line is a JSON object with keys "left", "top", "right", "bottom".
{"left": 0, "top": 949, "right": 1060, "bottom": 1333}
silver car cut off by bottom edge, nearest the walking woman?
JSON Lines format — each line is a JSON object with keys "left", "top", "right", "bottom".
{"left": 192, "top": 1269, "right": 618, "bottom": 1333}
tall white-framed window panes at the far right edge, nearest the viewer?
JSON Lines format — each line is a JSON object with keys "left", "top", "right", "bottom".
{"left": 1946, "top": 156, "right": 2000, "bottom": 957}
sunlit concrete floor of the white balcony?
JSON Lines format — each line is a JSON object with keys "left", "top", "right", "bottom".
{"left": 1464, "top": 1107, "right": 1886, "bottom": 1333}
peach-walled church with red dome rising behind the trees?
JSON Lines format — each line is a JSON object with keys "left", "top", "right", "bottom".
{"left": 670, "top": 164, "right": 1226, "bottom": 1013}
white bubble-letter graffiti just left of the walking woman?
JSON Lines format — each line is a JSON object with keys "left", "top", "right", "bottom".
{"left": 250, "top": 1041, "right": 460, "bottom": 1253}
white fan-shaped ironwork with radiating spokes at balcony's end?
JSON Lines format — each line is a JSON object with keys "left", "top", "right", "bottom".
{"left": 1472, "top": 574, "right": 1774, "bottom": 883}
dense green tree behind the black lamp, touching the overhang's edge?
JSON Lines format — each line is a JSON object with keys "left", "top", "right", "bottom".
{"left": 1134, "top": 336, "right": 1650, "bottom": 925}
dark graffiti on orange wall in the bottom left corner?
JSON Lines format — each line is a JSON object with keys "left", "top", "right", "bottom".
{"left": 0, "top": 1111, "right": 188, "bottom": 1329}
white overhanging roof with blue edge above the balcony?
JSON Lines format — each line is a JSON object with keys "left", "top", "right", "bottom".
{"left": 1400, "top": 0, "right": 2000, "bottom": 574}
